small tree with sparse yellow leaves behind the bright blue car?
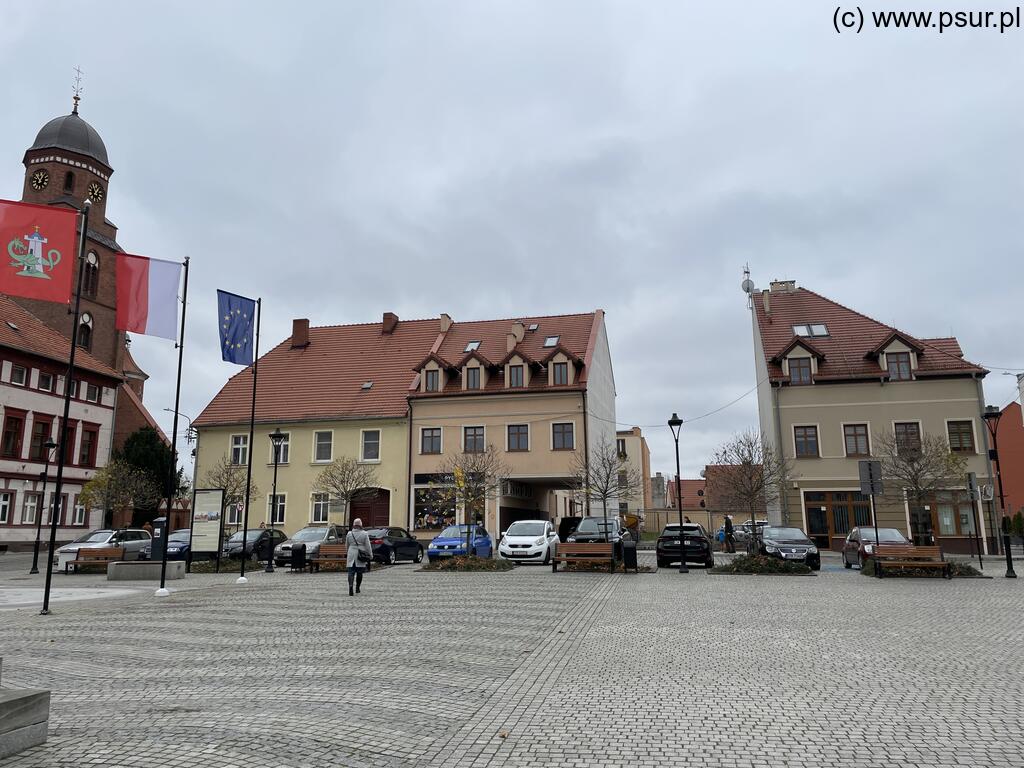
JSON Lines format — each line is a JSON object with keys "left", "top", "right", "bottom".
{"left": 428, "top": 445, "right": 509, "bottom": 555}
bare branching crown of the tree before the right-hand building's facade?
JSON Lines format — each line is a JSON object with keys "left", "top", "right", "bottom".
{"left": 872, "top": 432, "right": 967, "bottom": 540}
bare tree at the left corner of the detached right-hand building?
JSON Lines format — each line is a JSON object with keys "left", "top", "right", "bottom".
{"left": 707, "top": 429, "right": 793, "bottom": 552}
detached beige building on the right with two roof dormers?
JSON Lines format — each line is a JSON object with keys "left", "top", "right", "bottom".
{"left": 752, "top": 282, "right": 993, "bottom": 552}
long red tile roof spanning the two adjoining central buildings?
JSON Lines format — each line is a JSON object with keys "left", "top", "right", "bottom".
{"left": 195, "top": 310, "right": 603, "bottom": 434}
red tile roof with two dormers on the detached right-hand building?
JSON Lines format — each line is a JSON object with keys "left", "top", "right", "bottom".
{"left": 753, "top": 288, "right": 988, "bottom": 381}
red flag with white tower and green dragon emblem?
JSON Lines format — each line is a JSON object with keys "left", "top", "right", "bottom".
{"left": 0, "top": 200, "right": 78, "bottom": 304}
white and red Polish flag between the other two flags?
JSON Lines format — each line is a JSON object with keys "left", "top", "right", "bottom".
{"left": 116, "top": 253, "right": 182, "bottom": 341}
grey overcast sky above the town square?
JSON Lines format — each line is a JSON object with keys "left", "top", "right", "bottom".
{"left": 0, "top": 0, "right": 1024, "bottom": 476}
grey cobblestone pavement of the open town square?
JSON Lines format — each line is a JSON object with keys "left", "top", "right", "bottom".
{"left": 0, "top": 565, "right": 1024, "bottom": 768}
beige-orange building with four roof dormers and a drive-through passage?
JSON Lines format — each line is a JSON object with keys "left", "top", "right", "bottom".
{"left": 409, "top": 309, "right": 617, "bottom": 532}
